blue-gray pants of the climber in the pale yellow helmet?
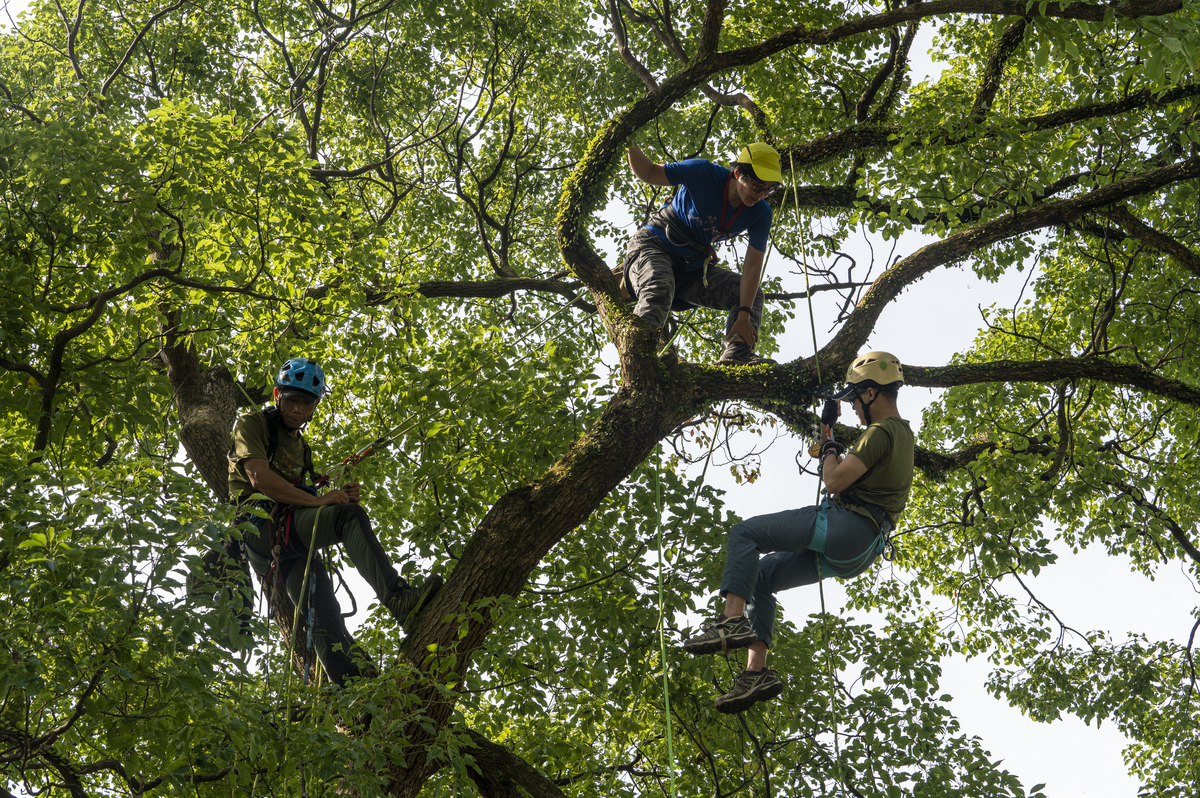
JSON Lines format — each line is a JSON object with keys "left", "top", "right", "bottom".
{"left": 721, "top": 502, "right": 880, "bottom": 647}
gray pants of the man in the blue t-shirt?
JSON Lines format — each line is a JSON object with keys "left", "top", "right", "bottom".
{"left": 625, "top": 227, "right": 763, "bottom": 335}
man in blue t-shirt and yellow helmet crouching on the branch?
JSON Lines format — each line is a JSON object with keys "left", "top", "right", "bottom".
{"left": 622, "top": 142, "right": 782, "bottom": 364}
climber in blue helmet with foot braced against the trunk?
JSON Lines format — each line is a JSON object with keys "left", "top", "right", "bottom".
{"left": 229, "top": 358, "right": 442, "bottom": 682}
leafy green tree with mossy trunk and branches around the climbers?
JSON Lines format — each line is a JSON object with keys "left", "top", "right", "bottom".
{"left": 0, "top": 0, "right": 1200, "bottom": 798}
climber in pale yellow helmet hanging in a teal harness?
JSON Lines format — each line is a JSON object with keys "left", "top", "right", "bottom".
{"left": 683, "top": 352, "right": 913, "bottom": 713}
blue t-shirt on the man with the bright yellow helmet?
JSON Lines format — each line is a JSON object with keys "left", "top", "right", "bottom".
{"left": 647, "top": 158, "right": 770, "bottom": 271}
